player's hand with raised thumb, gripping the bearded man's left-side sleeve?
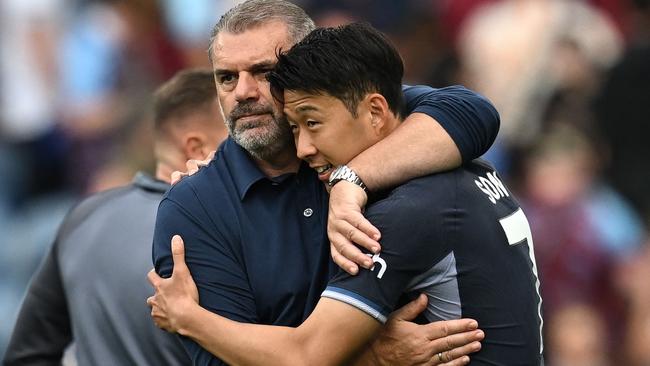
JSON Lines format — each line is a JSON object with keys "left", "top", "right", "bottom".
{"left": 147, "top": 235, "right": 199, "bottom": 332}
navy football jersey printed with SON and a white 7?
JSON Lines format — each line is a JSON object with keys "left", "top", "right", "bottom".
{"left": 323, "top": 160, "right": 543, "bottom": 366}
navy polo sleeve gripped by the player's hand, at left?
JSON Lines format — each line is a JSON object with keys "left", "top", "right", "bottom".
{"left": 153, "top": 181, "right": 257, "bottom": 365}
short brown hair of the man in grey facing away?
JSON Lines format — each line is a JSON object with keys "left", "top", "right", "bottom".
{"left": 153, "top": 68, "right": 217, "bottom": 134}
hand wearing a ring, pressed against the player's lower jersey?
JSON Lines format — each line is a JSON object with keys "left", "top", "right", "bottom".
{"left": 371, "top": 295, "right": 485, "bottom": 366}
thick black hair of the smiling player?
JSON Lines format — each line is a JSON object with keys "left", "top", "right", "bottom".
{"left": 268, "top": 23, "right": 404, "bottom": 117}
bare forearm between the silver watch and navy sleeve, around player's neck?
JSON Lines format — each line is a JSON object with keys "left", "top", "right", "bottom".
{"left": 348, "top": 113, "right": 461, "bottom": 191}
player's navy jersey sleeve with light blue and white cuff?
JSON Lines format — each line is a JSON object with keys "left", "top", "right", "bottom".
{"left": 322, "top": 182, "right": 449, "bottom": 323}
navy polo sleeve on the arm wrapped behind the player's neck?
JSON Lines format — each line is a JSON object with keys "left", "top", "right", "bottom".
{"left": 402, "top": 85, "right": 500, "bottom": 162}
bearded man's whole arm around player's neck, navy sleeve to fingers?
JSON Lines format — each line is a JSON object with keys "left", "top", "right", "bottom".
{"left": 327, "top": 86, "right": 500, "bottom": 274}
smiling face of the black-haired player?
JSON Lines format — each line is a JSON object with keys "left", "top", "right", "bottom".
{"left": 284, "top": 91, "right": 380, "bottom": 182}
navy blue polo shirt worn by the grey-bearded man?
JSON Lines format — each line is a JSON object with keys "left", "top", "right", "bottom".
{"left": 153, "top": 86, "right": 499, "bottom": 365}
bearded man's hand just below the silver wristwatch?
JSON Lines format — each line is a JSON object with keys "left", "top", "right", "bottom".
{"left": 327, "top": 181, "right": 381, "bottom": 275}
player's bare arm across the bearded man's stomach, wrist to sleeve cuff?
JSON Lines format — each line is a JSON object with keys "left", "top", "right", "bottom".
{"left": 177, "top": 299, "right": 380, "bottom": 365}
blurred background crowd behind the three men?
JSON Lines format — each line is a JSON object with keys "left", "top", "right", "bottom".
{"left": 0, "top": 0, "right": 650, "bottom": 366}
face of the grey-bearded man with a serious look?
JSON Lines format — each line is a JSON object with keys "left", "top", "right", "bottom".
{"left": 212, "top": 22, "right": 292, "bottom": 154}
